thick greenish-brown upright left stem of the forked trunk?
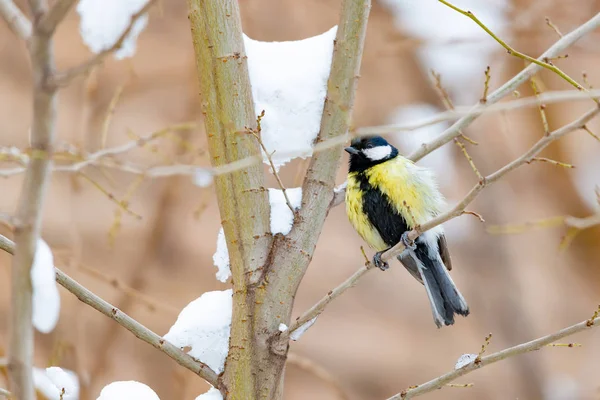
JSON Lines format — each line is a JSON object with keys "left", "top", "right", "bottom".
{"left": 188, "top": 0, "right": 272, "bottom": 400}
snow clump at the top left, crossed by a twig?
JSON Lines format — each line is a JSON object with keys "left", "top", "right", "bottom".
{"left": 77, "top": 0, "right": 148, "bottom": 60}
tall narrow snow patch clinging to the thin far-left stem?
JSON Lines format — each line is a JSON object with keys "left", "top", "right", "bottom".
{"left": 31, "top": 239, "right": 60, "bottom": 333}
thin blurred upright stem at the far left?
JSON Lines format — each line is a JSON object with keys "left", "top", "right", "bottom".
{"left": 9, "top": 0, "right": 56, "bottom": 400}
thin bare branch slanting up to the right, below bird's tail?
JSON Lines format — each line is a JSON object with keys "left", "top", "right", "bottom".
{"left": 387, "top": 318, "right": 600, "bottom": 400}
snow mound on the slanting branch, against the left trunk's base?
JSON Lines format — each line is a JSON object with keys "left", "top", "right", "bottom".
{"left": 164, "top": 289, "right": 233, "bottom": 374}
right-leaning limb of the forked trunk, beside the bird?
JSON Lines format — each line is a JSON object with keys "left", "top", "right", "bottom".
{"left": 264, "top": 0, "right": 371, "bottom": 347}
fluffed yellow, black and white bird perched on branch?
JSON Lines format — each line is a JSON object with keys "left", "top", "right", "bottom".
{"left": 344, "top": 136, "right": 469, "bottom": 328}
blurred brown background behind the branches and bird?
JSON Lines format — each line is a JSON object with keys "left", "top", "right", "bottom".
{"left": 0, "top": 0, "right": 600, "bottom": 400}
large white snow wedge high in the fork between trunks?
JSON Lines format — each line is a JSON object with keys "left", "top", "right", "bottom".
{"left": 244, "top": 26, "right": 337, "bottom": 169}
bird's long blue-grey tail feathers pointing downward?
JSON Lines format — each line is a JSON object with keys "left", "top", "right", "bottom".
{"left": 417, "top": 254, "right": 469, "bottom": 328}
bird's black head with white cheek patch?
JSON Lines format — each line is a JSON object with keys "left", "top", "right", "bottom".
{"left": 344, "top": 136, "right": 398, "bottom": 172}
